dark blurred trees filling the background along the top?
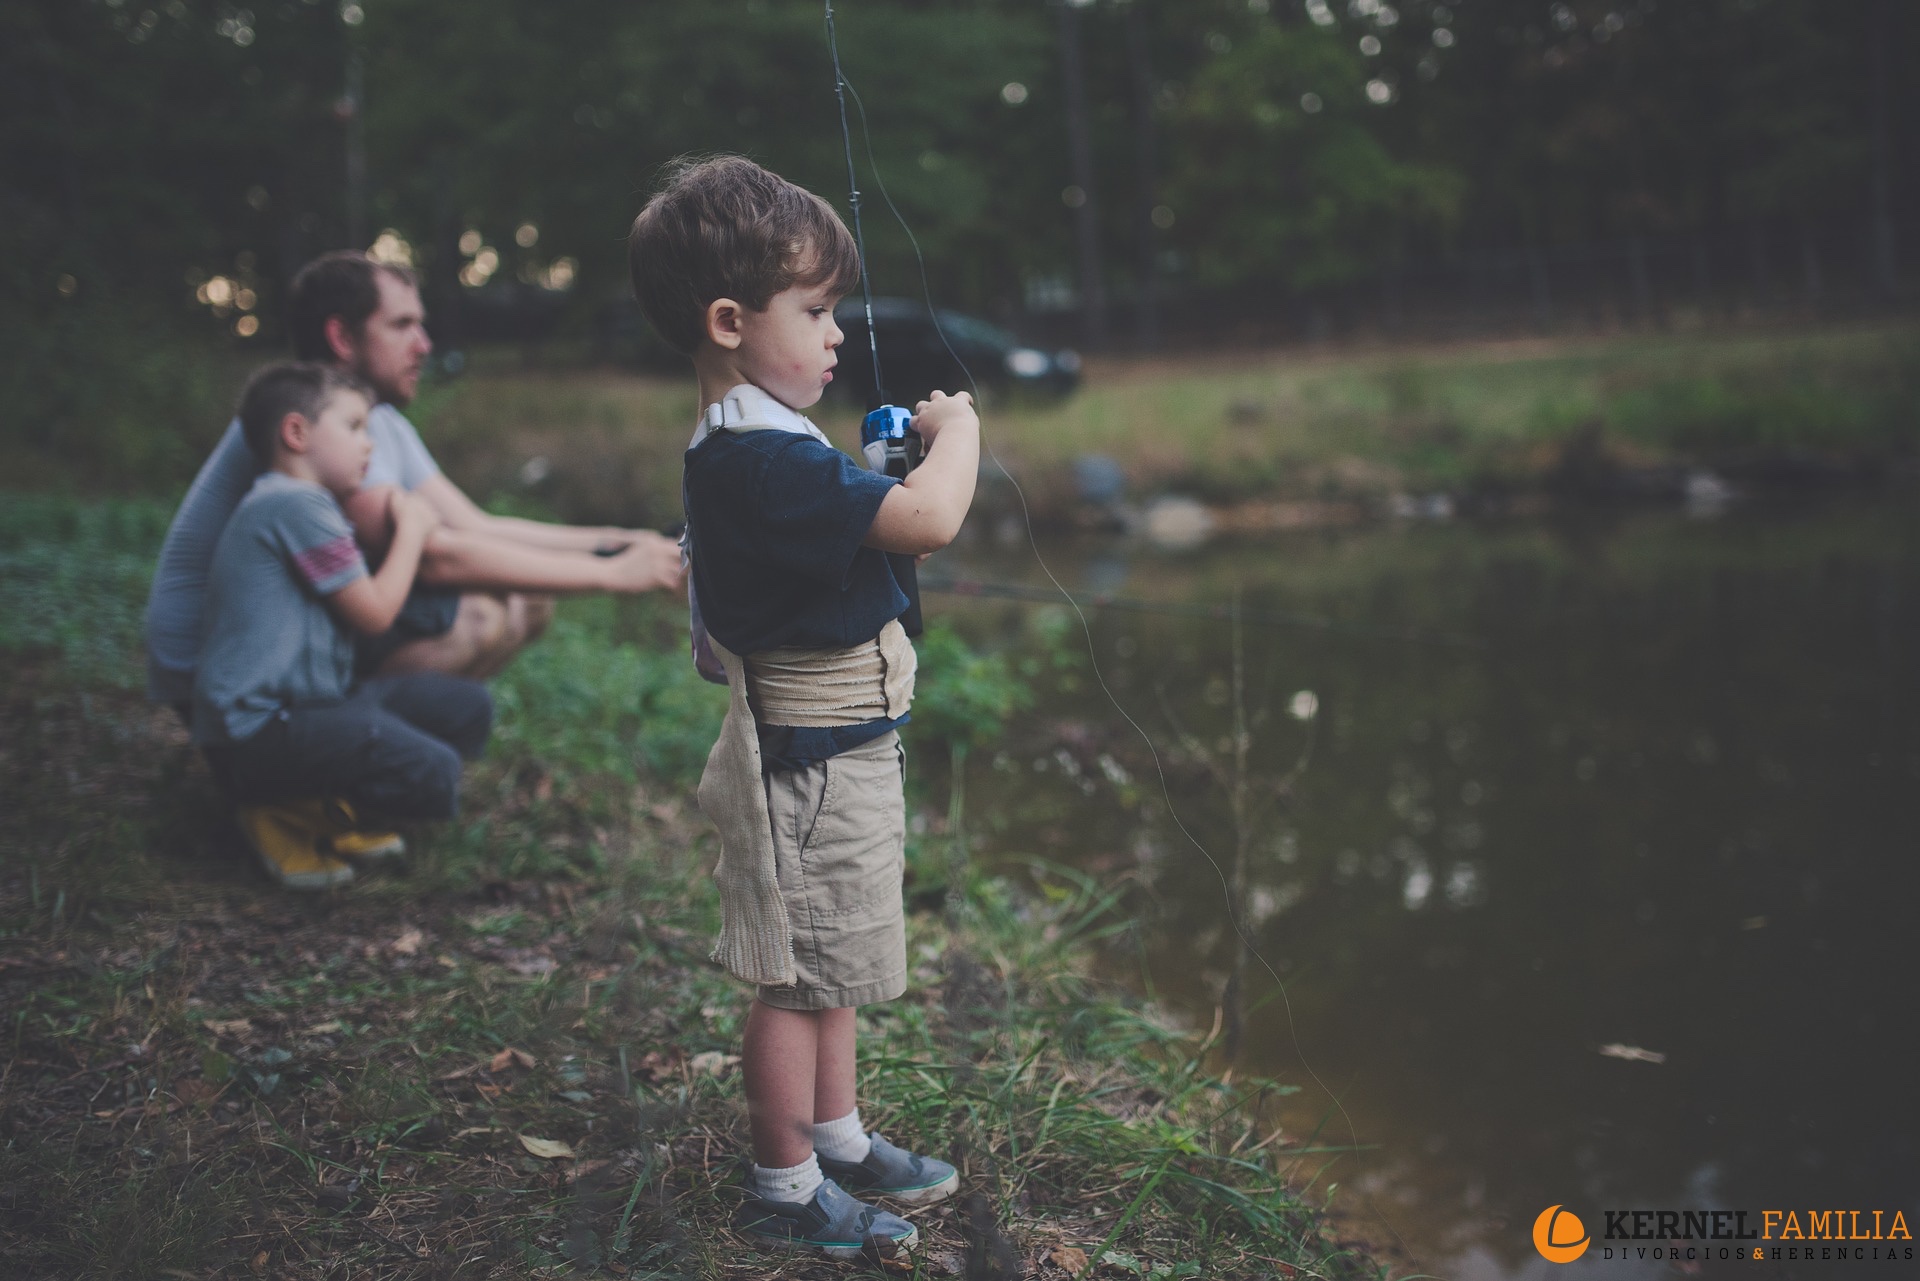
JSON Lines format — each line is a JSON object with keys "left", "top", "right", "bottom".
{"left": 0, "top": 0, "right": 1920, "bottom": 484}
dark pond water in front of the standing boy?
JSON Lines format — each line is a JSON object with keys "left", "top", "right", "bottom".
{"left": 927, "top": 499, "right": 1920, "bottom": 1279}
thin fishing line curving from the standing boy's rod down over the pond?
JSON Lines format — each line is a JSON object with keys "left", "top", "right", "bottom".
{"left": 826, "top": 0, "right": 1411, "bottom": 1256}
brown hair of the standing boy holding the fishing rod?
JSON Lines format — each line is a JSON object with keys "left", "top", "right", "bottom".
{"left": 626, "top": 156, "right": 860, "bottom": 355}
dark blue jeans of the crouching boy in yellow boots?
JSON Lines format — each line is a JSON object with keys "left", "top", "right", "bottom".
{"left": 205, "top": 672, "right": 493, "bottom": 820}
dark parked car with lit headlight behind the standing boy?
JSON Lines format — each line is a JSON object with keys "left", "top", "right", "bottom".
{"left": 833, "top": 296, "right": 1081, "bottom": 405}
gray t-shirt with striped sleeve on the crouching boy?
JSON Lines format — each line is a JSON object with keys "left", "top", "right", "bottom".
{"left": 194, "top": 472, "right": 367, "bottom": 745}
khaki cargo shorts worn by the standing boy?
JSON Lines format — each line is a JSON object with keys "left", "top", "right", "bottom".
{"left": 758, "top": 730, "right": 906, "bottom": 1010}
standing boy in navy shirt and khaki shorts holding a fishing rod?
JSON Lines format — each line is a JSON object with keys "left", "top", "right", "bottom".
{"left": 628, "top": 156, "right": 979, "bottom": 1258}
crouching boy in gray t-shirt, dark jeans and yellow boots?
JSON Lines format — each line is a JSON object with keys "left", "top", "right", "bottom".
{"left": 192, "top": 361, "right": 493, "bottom": 889}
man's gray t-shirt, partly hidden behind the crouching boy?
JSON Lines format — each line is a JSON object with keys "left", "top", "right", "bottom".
{"left": 146, "top": 405, "right": 440, "bottom": 703}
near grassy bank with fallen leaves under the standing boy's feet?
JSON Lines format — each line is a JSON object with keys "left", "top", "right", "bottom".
{"left": 0, "top": 495, "right": 1373, "bottom": 1277}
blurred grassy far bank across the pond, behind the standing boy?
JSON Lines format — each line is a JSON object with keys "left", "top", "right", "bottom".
{"left": 419, "top": 323, "right": 1920, "bottom": 522}
